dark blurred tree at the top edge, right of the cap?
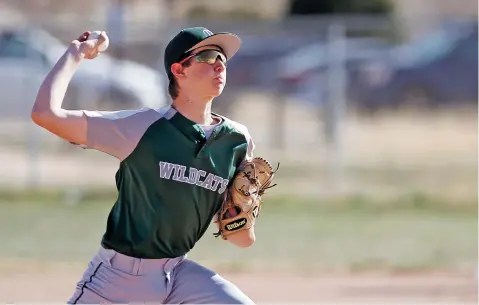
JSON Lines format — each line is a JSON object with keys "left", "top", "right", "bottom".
{"left": 288, "top": 0, "right": 394, "bottom": 15}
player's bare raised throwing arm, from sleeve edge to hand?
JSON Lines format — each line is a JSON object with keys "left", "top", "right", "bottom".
{"left": 31, "top": 32, "right": 105, "bottom": 144}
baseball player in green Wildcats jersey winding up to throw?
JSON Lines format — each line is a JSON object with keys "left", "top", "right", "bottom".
{"left": 31, "top": 27, "right": 273, "bottom": 304}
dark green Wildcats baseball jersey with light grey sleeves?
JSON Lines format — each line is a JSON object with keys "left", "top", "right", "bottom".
{"left": 79, "top": 106, "right": 254, "bottom": 258}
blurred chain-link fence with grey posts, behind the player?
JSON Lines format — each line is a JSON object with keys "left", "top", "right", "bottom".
{"left": 0, "top": 6, "right": 477, "bottom": 200}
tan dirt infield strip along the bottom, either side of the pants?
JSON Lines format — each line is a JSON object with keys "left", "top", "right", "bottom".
{"left": 0, "top": 262, "right": 477, "bottom": 304}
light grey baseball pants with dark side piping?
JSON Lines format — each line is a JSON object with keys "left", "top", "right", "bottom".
{"left": 68, "top": 248, "right": 254, "bottom": 304}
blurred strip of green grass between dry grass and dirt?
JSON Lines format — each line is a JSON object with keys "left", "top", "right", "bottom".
{"left": 0, "top": 191, "right": 477, "bottom": 273}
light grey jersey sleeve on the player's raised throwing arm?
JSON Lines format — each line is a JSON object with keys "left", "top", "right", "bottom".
{"left": 79, "top": 108, "right": 160, "bottom": 160}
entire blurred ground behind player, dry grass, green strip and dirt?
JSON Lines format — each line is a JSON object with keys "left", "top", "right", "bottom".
{"left": 0, "top": 108, "right": 478, "bottom": 304}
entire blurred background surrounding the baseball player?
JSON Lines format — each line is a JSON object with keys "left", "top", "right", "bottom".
{"left": 0, "top": 0, "right": 478, "bottom": 304}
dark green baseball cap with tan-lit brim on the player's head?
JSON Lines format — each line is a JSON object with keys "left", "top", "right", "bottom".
{"left": 164, "top": 27, "right": 241, "bottom": 79}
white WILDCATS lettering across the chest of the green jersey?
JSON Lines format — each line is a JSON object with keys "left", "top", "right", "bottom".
{"left": 159, "top": 161, "right": 229, "bottom": 194}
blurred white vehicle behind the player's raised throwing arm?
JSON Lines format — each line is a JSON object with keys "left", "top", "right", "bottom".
{"left": 0, "top": 28, "right": 168, "bottom": 118}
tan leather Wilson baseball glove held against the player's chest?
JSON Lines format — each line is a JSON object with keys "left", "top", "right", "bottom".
{"left": 215, "top": 157, "right": 279, "bottom": 239}
